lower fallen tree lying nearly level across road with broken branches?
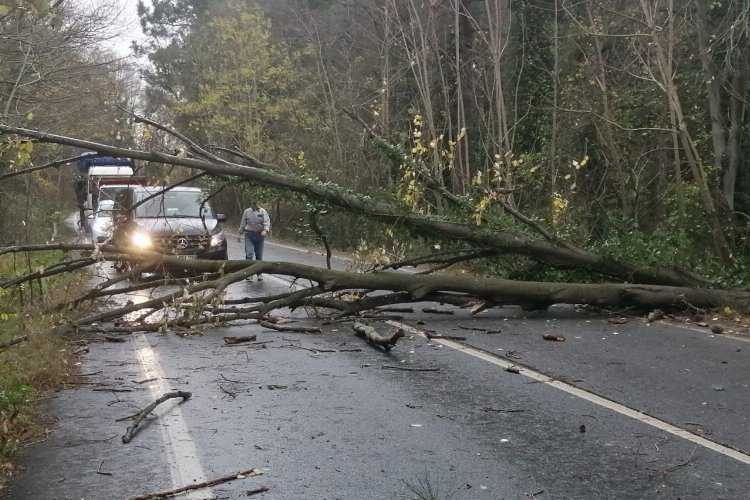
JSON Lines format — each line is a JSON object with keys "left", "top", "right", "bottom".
{"left": 0, "top": 245, "right": 750, "bottom": 331}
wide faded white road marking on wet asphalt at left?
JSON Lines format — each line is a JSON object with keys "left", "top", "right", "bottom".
{"left": 133, "top": 334, "right": 213, "bottom": 499}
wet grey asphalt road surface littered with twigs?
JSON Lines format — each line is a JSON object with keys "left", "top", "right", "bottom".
{"left": 9, "top": 236, "right": 750, "bottom": 499}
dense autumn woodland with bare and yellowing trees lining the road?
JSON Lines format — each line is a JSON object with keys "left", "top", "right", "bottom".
{"left": 0, "top": 0, "right": 750, "bottom": 286}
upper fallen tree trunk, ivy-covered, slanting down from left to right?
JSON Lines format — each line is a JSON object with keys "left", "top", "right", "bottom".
{"left": 0, "top": 124, "right": 710, "bottom": 286}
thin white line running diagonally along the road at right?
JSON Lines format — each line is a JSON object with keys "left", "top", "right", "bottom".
{"left": 387, "top": 321, "right": 750, "bottom": 465}
